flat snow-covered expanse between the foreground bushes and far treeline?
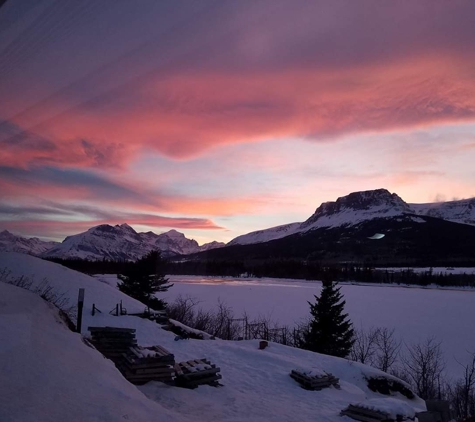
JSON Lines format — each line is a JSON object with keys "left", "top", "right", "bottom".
{"left": 162, "top": 276, "right": 475, "bottom": 376}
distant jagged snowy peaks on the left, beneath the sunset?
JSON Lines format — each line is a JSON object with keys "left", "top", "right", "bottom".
{"left": 42, "top": 224, "right": 223, "bottom": 260}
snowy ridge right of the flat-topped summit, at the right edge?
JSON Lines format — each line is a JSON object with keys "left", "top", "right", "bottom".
{"left": 410, "top": 198, "right": 475, "bottom": 225}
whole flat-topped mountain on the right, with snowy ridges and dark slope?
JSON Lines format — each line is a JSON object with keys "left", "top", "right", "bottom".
{"left": 200, "top": 189, "right": 475, "bottom": 266}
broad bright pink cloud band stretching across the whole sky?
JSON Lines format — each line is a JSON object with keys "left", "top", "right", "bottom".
{"left": 0, "top": 55, "right": 475, "bottom": 168}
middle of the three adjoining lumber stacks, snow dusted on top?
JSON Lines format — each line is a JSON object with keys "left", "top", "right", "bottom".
{"left": 118, "top": 346, "right": 175, "bottom": 385}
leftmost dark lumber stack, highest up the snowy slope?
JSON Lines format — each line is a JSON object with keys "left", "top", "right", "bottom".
{"left": 88, "top": 327, "right": 137, "bottom": 363}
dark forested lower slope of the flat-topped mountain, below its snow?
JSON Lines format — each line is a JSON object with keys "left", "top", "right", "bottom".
{"left": 199, "top": 214, "right": 475, "bottom": 266}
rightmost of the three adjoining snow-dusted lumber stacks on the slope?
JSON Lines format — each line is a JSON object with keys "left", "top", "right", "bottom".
{"left": 175, "top": 359, "right": 221, "bottom": 388}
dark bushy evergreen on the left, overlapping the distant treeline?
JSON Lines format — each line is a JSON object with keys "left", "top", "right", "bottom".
{"left": 117, "top": 251, "right": 173, "bottom": 310}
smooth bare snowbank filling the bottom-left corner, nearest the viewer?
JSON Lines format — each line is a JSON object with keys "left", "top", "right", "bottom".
{"left": 0, "top": 283, "right": 180, "bottom": 422}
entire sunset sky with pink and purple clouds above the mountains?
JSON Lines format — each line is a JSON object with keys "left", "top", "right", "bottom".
{"left": 0, "top": 0, "right": 475, "bottom": 244}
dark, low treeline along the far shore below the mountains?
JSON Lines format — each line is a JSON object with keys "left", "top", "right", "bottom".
{"left": 45, "top": 258, "right": 475, "bottom": 287}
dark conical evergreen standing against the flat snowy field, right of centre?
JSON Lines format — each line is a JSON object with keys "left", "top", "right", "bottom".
{"left": 302, "top": 281, "right": 354, "bottom": 357}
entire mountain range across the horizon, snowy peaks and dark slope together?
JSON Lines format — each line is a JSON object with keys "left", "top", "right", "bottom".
{"left": 0, "top": 189, "right": 475, "bottom": 262}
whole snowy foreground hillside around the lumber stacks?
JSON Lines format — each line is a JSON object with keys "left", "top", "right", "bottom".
{"left": 0, "top": 253, "right": 425, "bottom": 422}
